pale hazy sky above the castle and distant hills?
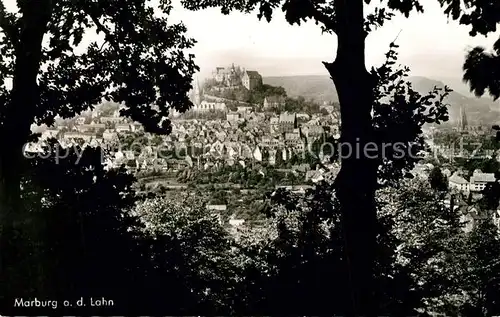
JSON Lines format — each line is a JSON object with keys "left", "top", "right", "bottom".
{"left": 172, "top": 0, "right": 500, "bottom": 78}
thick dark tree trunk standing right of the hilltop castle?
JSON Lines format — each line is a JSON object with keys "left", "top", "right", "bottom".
{"left": 325, "top": 0, "right": 378, "bottom": 316}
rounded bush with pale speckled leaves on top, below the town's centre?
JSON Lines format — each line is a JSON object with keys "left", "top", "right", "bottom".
{"left": 134, "top": 195, "right": 238, "bottom": 313}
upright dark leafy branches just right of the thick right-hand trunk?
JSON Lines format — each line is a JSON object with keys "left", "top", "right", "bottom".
{"left": 372, "top": 44, "right": 451, "bottom": 185}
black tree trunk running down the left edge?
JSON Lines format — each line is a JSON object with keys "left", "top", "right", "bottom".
{"left": 0, "top": 0, "right": 52, "bottom": 308}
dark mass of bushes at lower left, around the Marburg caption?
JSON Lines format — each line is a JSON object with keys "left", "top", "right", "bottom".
{"left": 10, "top": 140, "right": 239, "bottom": 315}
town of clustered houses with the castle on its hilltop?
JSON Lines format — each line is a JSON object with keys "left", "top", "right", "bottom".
{"left": 26, "top": 64, "right": 500, "bottom": 232}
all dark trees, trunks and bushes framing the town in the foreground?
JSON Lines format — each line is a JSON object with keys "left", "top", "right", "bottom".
{"left": 0, "top": 0, "right": 500, "bottom": 317}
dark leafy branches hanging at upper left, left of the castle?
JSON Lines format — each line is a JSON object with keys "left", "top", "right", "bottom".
{"left": 0, "top": 1, "right": 198, "bottom": 133}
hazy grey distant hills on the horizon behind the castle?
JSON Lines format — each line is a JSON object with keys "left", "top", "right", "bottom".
{"left": 263, "top": 76, "right": 500, "bottom": 125}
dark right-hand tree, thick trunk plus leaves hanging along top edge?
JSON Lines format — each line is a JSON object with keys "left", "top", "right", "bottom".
{"left": 182, "top": 0, "right": 499, "bottom": 315}
